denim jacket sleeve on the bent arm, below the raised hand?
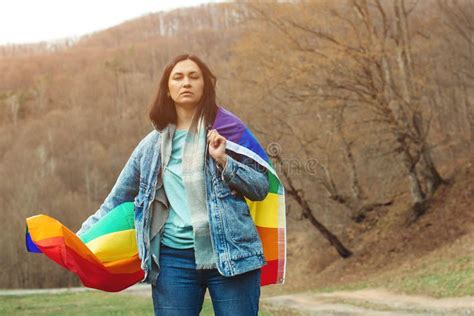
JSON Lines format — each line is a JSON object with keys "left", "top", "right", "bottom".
{"left": 219, "top": 153, "right": 269, "bottom": 201}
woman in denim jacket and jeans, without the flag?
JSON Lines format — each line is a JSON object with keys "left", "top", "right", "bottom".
{"left": 77, "top": 55, "right": 269, "bottom": 315}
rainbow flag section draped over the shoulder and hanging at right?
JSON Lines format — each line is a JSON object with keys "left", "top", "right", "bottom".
{"left": 212, "top": 107, "right": 286, "bottom": 286}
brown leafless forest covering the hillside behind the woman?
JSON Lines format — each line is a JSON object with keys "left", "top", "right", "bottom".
{"left": 0, "top": 0, "right": 474, "bottom": 288}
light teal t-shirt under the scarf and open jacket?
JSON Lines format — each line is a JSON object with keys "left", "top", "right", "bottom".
{"left": 161, "top": 130, "right": 194, "bottom": 249}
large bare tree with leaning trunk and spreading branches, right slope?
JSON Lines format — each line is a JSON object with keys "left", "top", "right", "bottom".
{"left": 253, "top": 0, "right": 444, "bottom": 218}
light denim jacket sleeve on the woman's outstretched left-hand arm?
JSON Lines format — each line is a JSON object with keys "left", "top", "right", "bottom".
{"left": 76, "top": 147, "right": 140, "bottom": 236}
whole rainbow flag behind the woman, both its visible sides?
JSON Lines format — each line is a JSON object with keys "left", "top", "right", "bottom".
{"left": 26, "top": 107, "right": 286, "bottom": 292}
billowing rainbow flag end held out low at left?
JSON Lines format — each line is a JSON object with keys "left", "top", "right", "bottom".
{"left": 26, "top": 202, "right": 144, "bottom": 292}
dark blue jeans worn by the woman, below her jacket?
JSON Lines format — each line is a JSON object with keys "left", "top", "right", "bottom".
{"left": 152, "top": 244, "right": 260, "bottom": 316}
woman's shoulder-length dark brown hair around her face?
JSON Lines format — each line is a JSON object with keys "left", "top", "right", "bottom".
{"left": 149, "top": 54, "right": 217, "bottom": 131}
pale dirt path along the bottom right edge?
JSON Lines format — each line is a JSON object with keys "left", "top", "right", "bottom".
{"left": 261, "top": 289, "right": 474, "bottom": 316}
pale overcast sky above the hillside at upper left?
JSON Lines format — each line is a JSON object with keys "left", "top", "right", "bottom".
{"left": 0, "top": 0, "right": 219, "bottom": 45}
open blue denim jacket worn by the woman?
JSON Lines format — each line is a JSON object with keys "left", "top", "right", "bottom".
{"left": 77, "top": 130, "right": 269, "bottom": 284}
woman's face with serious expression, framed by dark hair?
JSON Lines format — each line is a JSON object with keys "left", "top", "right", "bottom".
{"left": 168, "top": 59, "right": 204, "bottom": 107}
